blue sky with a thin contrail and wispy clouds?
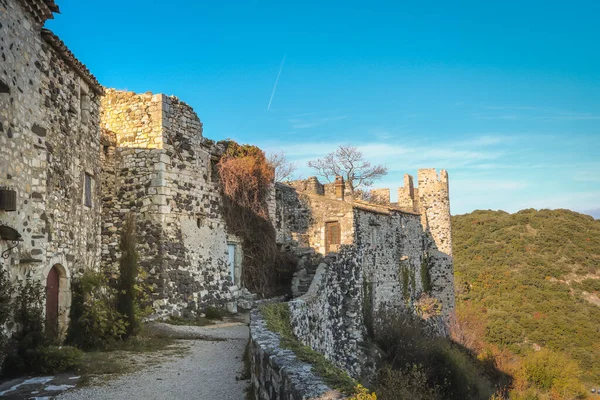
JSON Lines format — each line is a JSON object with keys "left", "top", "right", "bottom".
{"left": 47, "top": 0, "right": 600, "bottom": 217}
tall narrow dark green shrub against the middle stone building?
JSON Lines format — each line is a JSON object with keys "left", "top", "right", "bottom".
{"left": 117, "top": 214, "right": 140, "bottom": 337}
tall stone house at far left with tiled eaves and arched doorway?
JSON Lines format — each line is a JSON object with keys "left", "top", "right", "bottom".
{"left": 0, "top": 0, "right": 103, "bottom": 330}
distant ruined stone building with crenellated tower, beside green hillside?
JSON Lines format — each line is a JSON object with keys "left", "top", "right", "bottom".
{"left": 275, "top": 169, "right": 454, "bottom": 317}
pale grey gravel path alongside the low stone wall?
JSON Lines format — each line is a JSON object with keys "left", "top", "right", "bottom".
{"left": 58, "top": 324, "right": 248, "bottom": 400}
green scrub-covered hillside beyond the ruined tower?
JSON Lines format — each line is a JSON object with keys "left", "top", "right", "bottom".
{"left": 452, "top": 210, "right": 600, "bottom": 398}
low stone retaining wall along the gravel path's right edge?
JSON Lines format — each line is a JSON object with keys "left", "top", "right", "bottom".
{"left": 249, "top": 308, "right": 344, "bottom": 400}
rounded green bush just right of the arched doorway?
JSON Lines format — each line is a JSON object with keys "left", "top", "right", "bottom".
{"left": 67, "top": 270, "right": 127, "bottom": 350}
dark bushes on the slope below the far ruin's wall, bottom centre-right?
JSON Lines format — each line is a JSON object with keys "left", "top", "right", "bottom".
{"left": 375, "top": 312, "right": 493, "bottom": 400}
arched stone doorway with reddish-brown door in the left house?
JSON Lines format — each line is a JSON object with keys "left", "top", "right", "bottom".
{"left": 46, "top": 264, "right": 71, "bottom": 338}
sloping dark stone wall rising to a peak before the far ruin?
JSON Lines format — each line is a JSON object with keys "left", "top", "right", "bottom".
{"left": 288, "top": 246, "right": 366, "bottom": 378}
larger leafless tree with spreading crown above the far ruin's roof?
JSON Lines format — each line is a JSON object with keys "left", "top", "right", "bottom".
{"left": 308, "top": 145, "right": 387, "bottom": 192}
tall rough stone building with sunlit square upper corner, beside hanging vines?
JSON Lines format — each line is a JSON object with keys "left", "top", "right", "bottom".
{"left": 102, "top": 90, "right": 239, "bottom": 315}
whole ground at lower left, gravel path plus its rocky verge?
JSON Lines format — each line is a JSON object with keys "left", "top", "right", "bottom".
{"left": 0, "top": 322, "right": 249, "bottom": 400}
